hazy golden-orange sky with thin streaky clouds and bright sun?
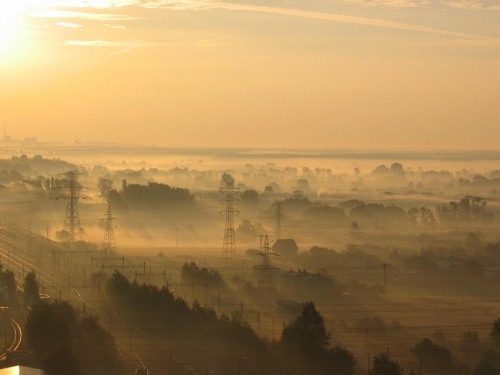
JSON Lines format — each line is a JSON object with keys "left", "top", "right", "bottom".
{"left": 0, "top": 0, "right": 500, "bottom": 150}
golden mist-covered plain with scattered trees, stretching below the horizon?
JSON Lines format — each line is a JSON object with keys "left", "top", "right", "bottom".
{"left": 0, "top": 144, "right": 500, "bottom": 374}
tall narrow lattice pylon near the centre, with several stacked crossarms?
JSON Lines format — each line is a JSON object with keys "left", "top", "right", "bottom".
{"left": 220, "top": 179, "right": 240, "bottom": 258}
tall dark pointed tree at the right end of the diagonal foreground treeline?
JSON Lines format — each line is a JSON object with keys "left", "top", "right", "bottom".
{"left": 281, "top": 301, "right": 330, "bottom": 357}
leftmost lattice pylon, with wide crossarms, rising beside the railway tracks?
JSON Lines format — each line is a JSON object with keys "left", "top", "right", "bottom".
{"left": 55, "top": 171, "right": 88, "bottom": 243}
